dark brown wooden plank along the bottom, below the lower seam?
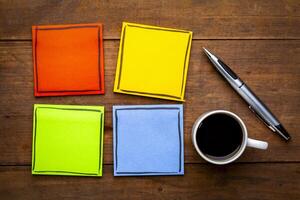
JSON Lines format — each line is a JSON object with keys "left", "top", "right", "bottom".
{"left": 0, "top": 163, "right": 300, "bottom": 200}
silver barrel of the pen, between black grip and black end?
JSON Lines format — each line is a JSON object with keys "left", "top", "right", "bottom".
{"left": 237, "top": 84, "right": 280, "bottom": 126}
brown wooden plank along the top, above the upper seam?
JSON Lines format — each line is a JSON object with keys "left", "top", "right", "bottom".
{"left": 0, "top": 0, "right": 300, "bottom": 40}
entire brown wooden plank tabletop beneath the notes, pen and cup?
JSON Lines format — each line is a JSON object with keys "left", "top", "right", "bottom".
{"left": 0, "top": 0, "right": 300, "bottom": 200}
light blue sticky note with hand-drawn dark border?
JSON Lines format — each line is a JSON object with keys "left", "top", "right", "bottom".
{"left": 113, "top": 104, "right": 184, "bottom": 176}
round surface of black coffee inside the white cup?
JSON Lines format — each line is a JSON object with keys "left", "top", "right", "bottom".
{"left": 196, "top": 113, "right": 243, "bottom": 158}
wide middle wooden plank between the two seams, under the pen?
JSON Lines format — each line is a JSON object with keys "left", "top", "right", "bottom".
{"left": 0, "top": 40, "right": 300, "bottom": 165}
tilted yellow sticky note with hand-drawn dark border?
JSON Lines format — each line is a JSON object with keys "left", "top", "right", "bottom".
{"left": 114, "top": 22, "right": 192, "bottom": 101}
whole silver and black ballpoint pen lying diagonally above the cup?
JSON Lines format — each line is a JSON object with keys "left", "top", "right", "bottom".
{"left": 203, "top": 47, "right": 291, "bottom": 141}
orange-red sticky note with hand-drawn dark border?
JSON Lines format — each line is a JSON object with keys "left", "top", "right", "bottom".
{"left": 32, "top": 23, "right": 104, "bottom": 96}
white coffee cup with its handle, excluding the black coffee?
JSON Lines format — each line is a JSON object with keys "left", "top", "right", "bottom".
{"left": 192, "top": 110, "right": 268, "bottom": 165}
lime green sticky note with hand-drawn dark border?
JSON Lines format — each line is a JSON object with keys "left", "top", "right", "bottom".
{"left": 32, "top": 104, "right": 104, "bottom": 176}
